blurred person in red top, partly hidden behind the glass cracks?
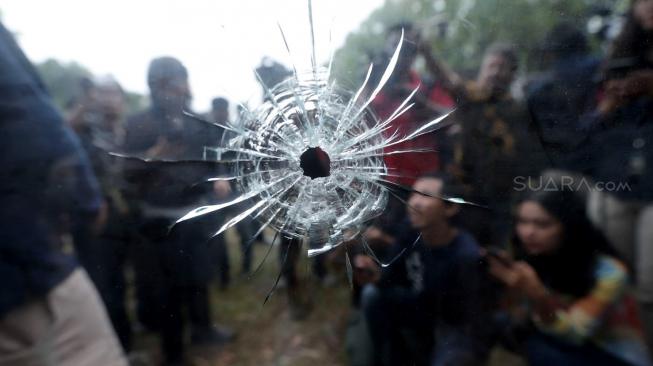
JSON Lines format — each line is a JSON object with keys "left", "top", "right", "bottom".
{"left": 367, "top": 23, "right": 454, "bottom": 262}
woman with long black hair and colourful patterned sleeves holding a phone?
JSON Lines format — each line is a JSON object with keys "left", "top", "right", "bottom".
{"left": 486, "top": 190, "right": 651, "bottom": 366}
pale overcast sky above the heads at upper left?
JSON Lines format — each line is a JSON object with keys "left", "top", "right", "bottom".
{"left": 0, "top": 0, "right": 383, "bottom": 112}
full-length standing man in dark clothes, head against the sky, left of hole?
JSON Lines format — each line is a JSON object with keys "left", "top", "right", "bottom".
{"left": 124, "top": 57, "right": 232, "bottom": 364}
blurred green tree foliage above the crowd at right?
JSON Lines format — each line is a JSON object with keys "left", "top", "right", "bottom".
{"left": 334, "top": 0, "right": 622, "bottom": 86}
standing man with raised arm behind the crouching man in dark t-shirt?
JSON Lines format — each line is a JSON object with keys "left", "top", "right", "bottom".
{"left": 422, "top": 43, "right": 548, "bottom": 246}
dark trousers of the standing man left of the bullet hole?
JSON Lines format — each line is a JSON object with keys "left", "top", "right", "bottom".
{"left": 134, "top": 219, "right": 215, "bottom": 363}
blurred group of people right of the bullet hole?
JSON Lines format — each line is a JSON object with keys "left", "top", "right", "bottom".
{"left": 349, "top": 0, "right": 653, "bottom": 365}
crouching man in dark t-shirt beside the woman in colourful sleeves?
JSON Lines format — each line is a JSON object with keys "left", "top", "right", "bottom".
{"left": 354, "top": 174, "right": 487, "bottom": 365}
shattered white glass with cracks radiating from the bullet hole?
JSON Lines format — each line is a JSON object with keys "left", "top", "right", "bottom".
{"left": 113, "top": 0, "right": 473, "bottom": 272}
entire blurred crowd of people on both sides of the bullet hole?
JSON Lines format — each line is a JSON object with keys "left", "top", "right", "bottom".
{"left": 0, "top": 0, "right": 653, "bottom": 366}
